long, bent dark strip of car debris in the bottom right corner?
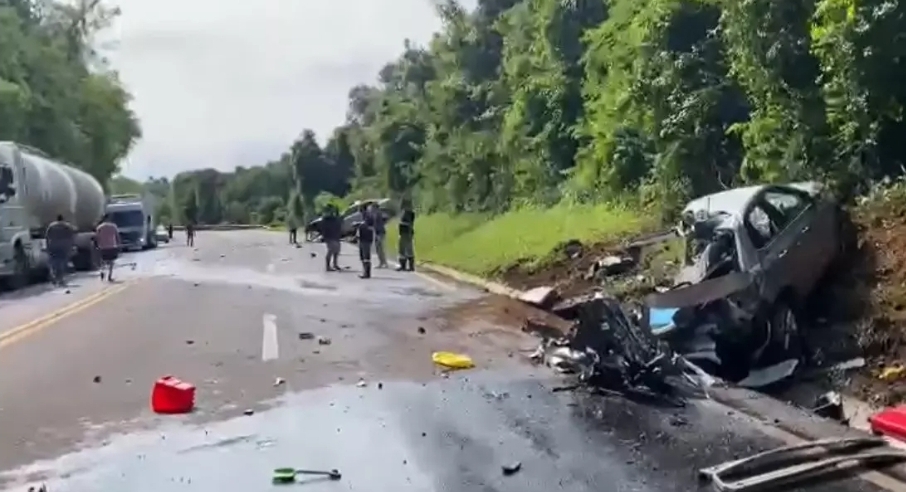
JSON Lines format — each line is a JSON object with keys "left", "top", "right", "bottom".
{"left": 698, "top": 437, "right": 906, "bottom": 492}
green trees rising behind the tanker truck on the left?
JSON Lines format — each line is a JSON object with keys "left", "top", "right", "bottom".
{"left": 0, "top": 0, "right": 140, "bottom": 182}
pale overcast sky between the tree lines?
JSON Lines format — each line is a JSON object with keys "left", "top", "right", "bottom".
{"left": 108, "top": 0, "right": 452, "bottom": 179}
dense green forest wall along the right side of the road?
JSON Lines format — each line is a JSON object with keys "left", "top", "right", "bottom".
{"left": 120, "top": 0, "right": 906, "bottom": 226}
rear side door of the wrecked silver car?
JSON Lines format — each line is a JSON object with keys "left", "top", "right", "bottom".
{"left": 762, "top": 187, "right": 824, "bottom": 299}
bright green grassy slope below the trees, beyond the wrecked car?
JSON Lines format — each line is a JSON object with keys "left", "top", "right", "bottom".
{"left": 387, "top": 204, "right": 654, "bottom": 277}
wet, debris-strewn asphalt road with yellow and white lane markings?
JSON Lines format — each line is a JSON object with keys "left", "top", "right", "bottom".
{"left": 0, "top": 231, "right": 881, "bottom": 492}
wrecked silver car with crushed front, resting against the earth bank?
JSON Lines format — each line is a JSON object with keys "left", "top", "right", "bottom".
{"left": 643, "top": 182, "right": 854, "bottom": 381}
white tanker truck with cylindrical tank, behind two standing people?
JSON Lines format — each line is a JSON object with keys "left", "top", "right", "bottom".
{"left": 0, "top": 142, "right": 106, "bottom": 288}
